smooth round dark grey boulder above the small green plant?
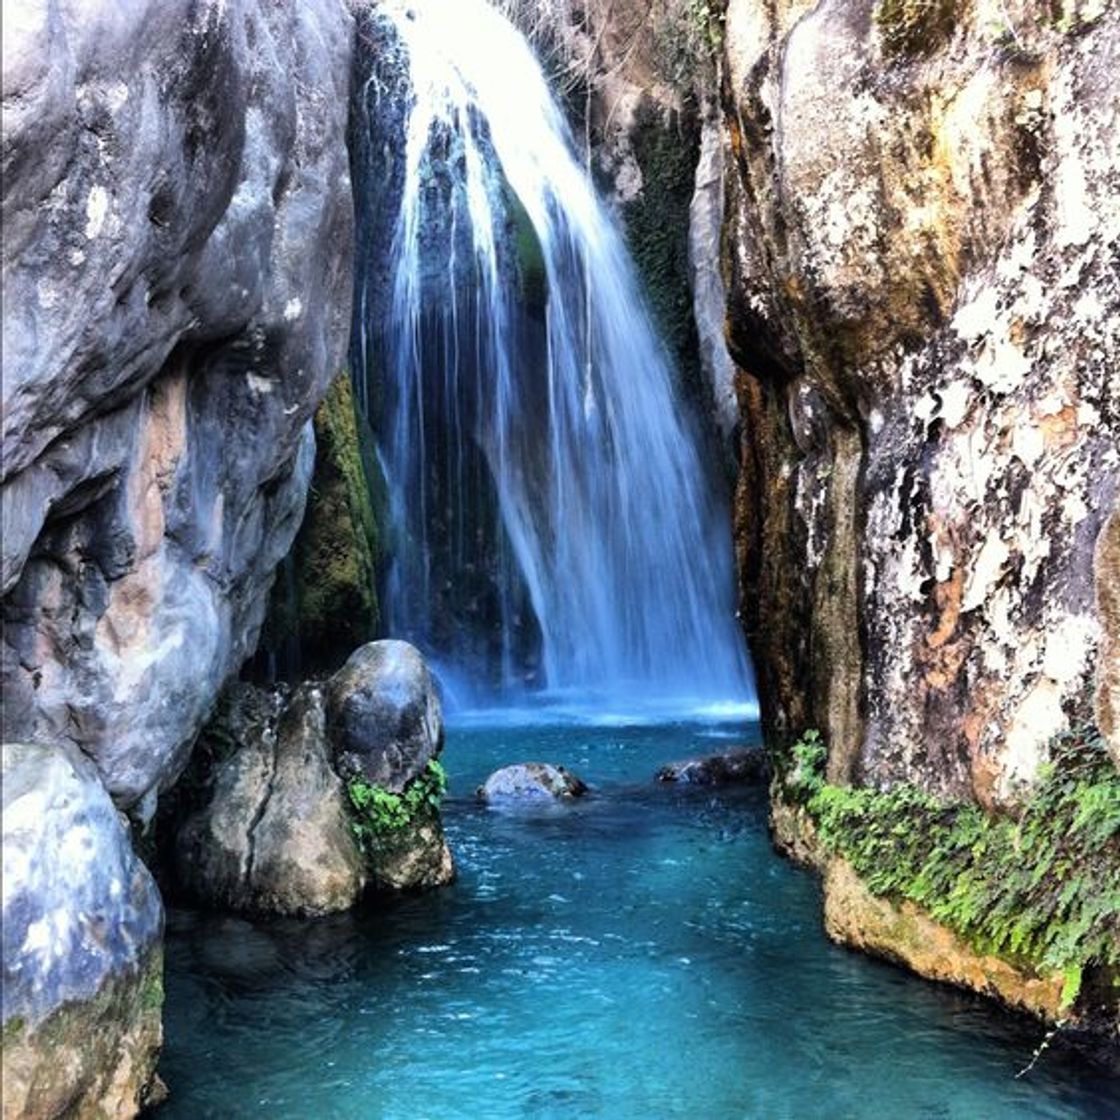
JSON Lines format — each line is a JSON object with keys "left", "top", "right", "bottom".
{"left": 327, "top": 641, "right": 444, "bottom": 793}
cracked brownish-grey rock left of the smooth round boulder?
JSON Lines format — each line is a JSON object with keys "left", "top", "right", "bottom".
{"left": 176, "top": 684, "right": 366, "bottom": 915}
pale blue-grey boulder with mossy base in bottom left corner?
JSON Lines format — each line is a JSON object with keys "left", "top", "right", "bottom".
{"left": 2, "top": 744, "right": 164, "bottom": 1120}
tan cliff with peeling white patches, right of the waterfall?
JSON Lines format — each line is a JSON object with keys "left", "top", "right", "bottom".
{"left": 726, "top": 0, "right": 1120, "bottom": 806}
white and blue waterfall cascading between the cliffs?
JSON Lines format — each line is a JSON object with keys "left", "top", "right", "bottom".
{"left": 353, "top": 0, "right": 750, "bottom": 702}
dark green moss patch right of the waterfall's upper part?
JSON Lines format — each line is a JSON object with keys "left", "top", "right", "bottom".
{"left": 623, "top": 105, "right": 700, "bottom": 389}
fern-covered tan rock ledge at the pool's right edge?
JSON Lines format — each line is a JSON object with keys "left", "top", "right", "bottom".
{"left": 771, "top": 731, "right": 1120, "bottom": 1046}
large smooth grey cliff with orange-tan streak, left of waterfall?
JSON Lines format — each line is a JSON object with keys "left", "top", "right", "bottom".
{"left": 0, "top": 0, "right": 353, "bottom": 808}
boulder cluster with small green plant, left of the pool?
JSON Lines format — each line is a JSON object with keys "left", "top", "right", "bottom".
{"left": 170, "top": 642, "right": 455, "bottom": 916}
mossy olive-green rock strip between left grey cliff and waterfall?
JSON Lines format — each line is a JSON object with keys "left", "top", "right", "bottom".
{"left": 263, "top": 371, "right": 381, "bottom": 672}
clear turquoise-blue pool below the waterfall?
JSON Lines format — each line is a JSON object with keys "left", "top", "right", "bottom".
{"left": 159, "top": 720, "right": 1120, "bottom": 1120}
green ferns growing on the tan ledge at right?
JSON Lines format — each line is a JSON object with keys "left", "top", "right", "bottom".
{"left": 783, "top": 731, "right": 1120, "bottom": 1005}
